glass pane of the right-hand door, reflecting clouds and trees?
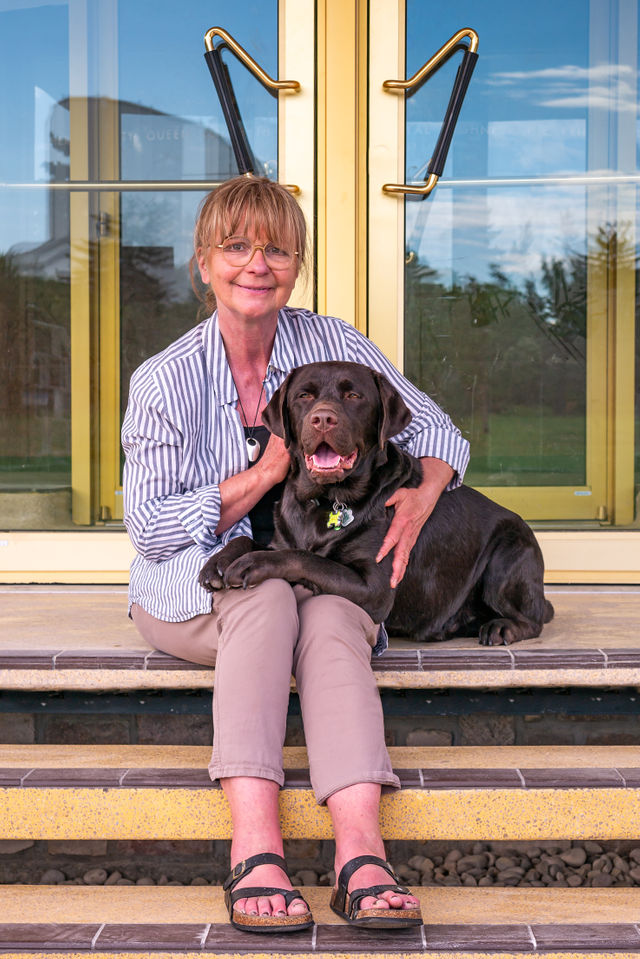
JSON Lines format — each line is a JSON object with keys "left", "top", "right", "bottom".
{"left": 405, "top": 0, "right": 637, "bottom": 506}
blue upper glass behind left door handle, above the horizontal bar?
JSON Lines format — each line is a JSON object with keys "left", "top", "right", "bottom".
{"left": 118, "top": 0, "right": 278, "bottom": 180}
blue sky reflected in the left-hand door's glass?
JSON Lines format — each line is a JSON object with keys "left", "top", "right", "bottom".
{"left": 0, "top": 0, "right": 278, "bottom": 252}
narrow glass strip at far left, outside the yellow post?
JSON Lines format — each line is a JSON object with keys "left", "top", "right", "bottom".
{"left": 0, "top": 2, "right": 71, "bottom": 529}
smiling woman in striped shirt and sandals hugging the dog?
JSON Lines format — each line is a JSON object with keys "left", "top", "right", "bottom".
{"left": 122, "top": 177, "right": 468, "bottom": 931}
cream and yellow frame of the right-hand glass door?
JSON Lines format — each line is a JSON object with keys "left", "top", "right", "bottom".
{"left": 368, "top": 0, "right": 636, "bottom": 528}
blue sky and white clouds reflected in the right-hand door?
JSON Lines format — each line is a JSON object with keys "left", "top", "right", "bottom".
{"left": 405, "top": 0, "right": 639, "bottom": 285}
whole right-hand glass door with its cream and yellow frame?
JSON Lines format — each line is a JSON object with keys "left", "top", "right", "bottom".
{"left": 369, "top": 0, "right": 638, "bottom": 524}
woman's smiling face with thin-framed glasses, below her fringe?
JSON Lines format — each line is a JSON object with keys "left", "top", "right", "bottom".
{"left": 198, "top": 227, "right": 299, "bottom": 330}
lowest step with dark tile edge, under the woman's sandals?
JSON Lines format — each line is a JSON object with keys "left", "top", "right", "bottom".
{"left": 0, "top": 886, "right": 640, "bottom": 959}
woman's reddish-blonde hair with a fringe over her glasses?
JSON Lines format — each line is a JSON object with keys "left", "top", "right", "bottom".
{"left": 189, "top": 176, "right": 309, "bottom": 311}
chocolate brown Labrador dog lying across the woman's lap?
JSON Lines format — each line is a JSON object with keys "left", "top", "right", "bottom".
{"left": 199, "top": 361, "right": 553, "bottom": 646}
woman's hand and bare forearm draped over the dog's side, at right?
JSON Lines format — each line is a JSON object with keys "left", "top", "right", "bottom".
{"left": 376, "top": 456, "right": 454, "bottom": 589}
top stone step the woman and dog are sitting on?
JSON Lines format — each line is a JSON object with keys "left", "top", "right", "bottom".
{"left": 0, "top": 586, "right": 640, "bottom": 691}
